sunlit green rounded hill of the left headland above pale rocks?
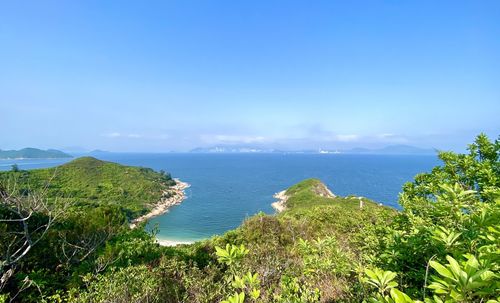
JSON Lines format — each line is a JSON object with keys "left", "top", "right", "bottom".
{"left": 0, "top": 157, "right": 174, "bottom": 218}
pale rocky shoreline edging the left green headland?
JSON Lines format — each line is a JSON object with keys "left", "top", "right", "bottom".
{"left": 129, "top": 179, "right": 191, "bottom": 228}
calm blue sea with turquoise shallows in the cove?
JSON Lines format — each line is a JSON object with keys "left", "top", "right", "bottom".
{"left": 0, "top": 153, "right": 438, "bottom": 241}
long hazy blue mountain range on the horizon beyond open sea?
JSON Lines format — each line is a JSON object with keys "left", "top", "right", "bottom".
{"left": 190, "top": 145, "right": 436, "bottom": 155}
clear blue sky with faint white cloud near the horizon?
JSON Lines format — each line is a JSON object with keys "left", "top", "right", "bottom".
{"left": 0, "top": 0, "right": 500, "bottom": 152}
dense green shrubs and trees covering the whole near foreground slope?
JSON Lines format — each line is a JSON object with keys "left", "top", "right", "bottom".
{"left": 0, "top": 135, "right": 500, "bottom": 303}
